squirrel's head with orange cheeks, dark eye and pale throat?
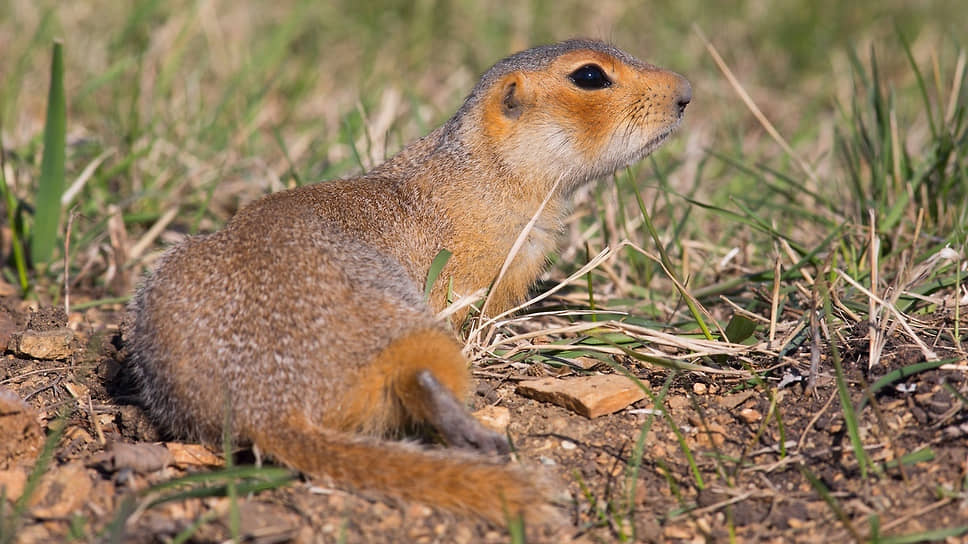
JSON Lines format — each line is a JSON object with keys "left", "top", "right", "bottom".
{"left": 454, "top": 40, "right": 692, "bottom": 198}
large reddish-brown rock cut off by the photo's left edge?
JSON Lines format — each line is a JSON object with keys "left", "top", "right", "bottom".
{"left": 0, "top": 386, "right": 44, "bottom": 469}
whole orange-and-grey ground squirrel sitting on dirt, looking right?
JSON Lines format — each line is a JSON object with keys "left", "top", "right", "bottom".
{"left": 125, "top": 40, "right": 692, "bottom": 523}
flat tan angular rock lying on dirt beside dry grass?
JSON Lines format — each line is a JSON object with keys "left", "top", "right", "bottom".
{"left": 517, "top": 374, "right": 645, "bottom": 419}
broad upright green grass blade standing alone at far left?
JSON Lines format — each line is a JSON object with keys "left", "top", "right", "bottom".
{"left": 30, "top": 42, "right": 67, "bottom": 269}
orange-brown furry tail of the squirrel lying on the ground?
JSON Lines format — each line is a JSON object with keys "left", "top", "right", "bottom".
{"left": 253, "top": 418, "right": 551, "bottom": 525}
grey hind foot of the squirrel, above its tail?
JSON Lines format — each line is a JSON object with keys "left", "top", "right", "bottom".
{"left": 417, "top": 370, "right": 511, "bottom": 455}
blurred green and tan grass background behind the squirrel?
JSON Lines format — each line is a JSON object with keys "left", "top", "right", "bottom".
{"left": 0, "top": 0, "right": 968, "bottom": 304}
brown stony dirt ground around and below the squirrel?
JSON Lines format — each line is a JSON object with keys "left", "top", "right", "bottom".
{"left": 0, "top": 296, "right": 968, "bottom": 543}
